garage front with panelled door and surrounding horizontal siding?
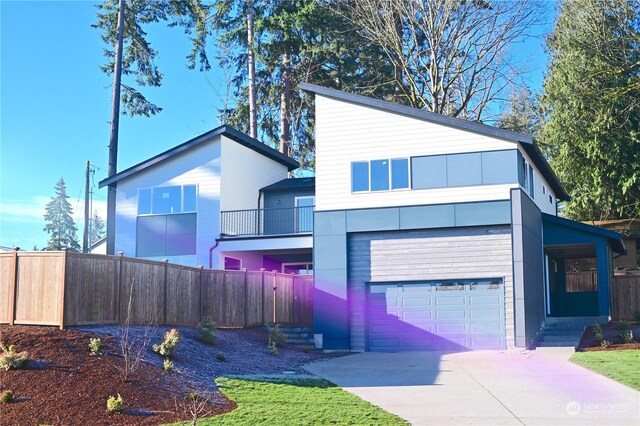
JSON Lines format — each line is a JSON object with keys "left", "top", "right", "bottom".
{"left": 348, "top": 226, "right": 513, "bottom": 351}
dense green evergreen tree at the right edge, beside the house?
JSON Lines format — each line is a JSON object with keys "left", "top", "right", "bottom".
{"left": 541, "top": 0, "right": 640, "bottom": 220}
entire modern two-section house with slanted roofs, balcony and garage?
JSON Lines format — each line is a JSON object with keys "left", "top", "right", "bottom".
{"left": 100, "top": 84, "right": 624, "bottom": 351}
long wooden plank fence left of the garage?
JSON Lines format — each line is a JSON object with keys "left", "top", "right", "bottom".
{"left": 0, "top": 251, "right": 313, "bottom": 328}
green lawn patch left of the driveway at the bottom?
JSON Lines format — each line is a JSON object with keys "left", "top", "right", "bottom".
{"left": 172, "top": 377, "right": 407, "bottom": 425}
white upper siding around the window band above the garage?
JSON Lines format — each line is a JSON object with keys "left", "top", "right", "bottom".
{"left": 315, "top": 95, "right": 518, "bottom": 210}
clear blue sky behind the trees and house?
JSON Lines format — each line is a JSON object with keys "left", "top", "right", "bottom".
{"left": 0, "top": 0, "right": 552, "bottom": 250}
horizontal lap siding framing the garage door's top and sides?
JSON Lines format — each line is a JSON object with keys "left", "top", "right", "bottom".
{"left": 348, "top": 227, "right": 514, "bottom": 351}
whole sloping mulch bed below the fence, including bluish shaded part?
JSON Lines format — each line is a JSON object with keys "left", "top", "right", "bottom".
{"left": 0, "top": 326, "right": 323, "bottom": 425}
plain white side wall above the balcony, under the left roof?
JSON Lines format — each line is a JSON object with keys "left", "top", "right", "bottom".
{"left": 221, "top": 136, "right": 288, "bottom": 211}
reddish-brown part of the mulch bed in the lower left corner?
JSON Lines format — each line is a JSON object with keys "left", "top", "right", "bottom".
{"left": 0, "top": 326, "right": 235, "bottom": 425}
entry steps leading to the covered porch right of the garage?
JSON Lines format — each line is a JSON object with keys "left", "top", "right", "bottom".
{"left": 536, "top": 317, "right": 609, "bottom": 348}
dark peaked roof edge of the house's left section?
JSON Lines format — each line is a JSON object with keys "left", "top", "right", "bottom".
{"left": 99, "top": 124, "right": 300, "bottom": 188}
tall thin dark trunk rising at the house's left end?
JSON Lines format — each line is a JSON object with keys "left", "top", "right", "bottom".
{"left": 107, "top": 0, "right": 125, "bottom": 255}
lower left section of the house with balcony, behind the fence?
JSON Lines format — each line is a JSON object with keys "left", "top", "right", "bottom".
{"left": 100, "top": 126, "right": 314, "bottom": 272}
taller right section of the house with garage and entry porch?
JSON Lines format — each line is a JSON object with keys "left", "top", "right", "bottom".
{"left": 301, "top": 84, "right": 624, "bottom": 351}
